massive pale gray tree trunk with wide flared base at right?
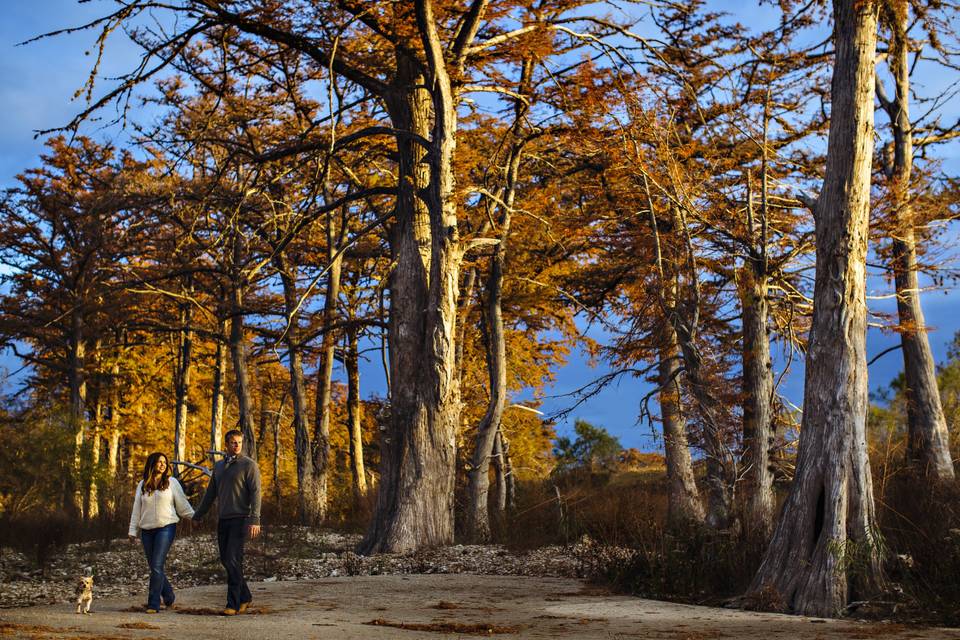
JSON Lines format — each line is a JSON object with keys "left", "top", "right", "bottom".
{"left": 750, "top": 0, "right": 882, "bottom": 616}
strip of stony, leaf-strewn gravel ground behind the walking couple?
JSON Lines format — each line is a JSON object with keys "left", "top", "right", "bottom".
{"left": 0, "top": 527, "right": 585, "bottom": 609}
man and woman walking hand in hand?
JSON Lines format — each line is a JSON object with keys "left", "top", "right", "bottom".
{"left": 129, "top": 429, "right": 260, "bottom": 616}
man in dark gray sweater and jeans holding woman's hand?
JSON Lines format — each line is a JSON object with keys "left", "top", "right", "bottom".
{"left": 193, "top": 429, "right": 260, "bottom": 616}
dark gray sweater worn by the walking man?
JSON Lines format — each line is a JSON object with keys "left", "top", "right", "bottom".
{"left": 193, "top": 455, "right": 260, "bottom": 525}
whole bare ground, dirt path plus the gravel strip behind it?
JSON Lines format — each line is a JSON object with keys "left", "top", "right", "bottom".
{"left": 0, "top": 529, "right": 960, "bottom": 640}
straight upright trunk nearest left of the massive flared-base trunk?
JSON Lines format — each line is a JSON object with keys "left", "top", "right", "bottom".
{"left": 738, "top": 261, "right": 774, "bottom": 542}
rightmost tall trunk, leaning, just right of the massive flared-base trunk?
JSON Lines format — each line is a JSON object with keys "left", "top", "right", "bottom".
{"left": 878, "top": 5, "right": 954, "bottom": 481}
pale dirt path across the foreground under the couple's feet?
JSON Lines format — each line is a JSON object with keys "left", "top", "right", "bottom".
{"left": 0, "top": 574, "right": 960, "bottom": 640}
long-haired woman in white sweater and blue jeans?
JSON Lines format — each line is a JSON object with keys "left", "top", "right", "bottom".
{"left": 130, "top": 451, "right": 193, "bottom": 613}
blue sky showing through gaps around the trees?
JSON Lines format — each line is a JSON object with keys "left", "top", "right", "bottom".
{"left": 0, "top": 0, "right": 960, "bottom": 450}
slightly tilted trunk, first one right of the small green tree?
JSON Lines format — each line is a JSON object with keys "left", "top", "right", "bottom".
{"left": 657, "top": 323, "right": 704, "bottom": 527}
